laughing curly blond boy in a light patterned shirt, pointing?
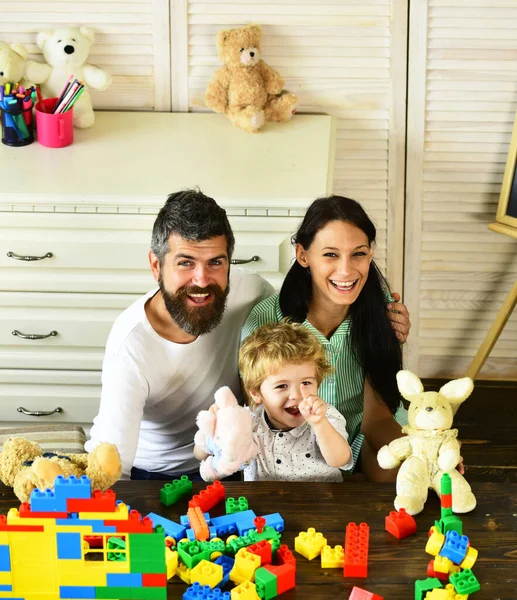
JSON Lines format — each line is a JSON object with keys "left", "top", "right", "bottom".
{"left": 239, "top": 321, "right": 353, "bottom": 481}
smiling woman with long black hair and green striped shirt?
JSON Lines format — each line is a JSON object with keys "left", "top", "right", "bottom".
{"left": 242, "top": 196, "right": 409, "bottom": 478}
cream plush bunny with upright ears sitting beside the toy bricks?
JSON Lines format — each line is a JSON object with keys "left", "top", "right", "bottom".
{"left": 377, "top": 371, "right": 476, "bottom": 515}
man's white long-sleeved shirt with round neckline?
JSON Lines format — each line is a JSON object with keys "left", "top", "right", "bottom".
{"left": 85, "top": 272, "right": 274, "bottom": 479}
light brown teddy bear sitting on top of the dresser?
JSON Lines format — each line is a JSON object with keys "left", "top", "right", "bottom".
{"left": 205, "top": 25, "right": 297, "bottom": 133}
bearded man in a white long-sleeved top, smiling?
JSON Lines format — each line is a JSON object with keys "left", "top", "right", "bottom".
{"left": 85, "top": 190, "right": 273, "bottom": 480}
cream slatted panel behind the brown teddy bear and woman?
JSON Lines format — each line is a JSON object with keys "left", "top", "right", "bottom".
{"left": 188, "top": 0, "right": 407, "bottom": 289}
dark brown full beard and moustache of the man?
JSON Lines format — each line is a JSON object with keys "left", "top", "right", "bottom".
{"left": 158, "top": 276, "right": 230, "bottom": 336}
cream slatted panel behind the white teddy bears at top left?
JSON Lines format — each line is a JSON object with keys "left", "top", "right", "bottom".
{"left": 0, "top": 0, "right": 170, "bottom": 110}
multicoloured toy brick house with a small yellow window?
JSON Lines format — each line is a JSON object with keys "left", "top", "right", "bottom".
{"left": 0, "top": 476, "right": 167, "bottom": 600}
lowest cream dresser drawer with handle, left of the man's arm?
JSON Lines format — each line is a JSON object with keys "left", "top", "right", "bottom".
{"left": 0, "top": 369, "right": 101, "bottom": 425}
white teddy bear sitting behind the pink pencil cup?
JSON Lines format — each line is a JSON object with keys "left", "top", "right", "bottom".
{"left": 25, "top": 26, "right": 111, "bottom": 129}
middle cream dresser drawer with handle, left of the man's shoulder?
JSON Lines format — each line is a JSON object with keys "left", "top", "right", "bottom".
{"left": 0, "top": 292, "right": 139, "bottom": 370}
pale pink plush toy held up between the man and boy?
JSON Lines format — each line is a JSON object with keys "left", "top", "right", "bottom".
{"left": 194, "top": 387, "right": 258, "bottom": 481}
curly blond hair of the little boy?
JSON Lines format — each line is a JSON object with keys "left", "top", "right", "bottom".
{"left": 239, "top": 319, "right": 332, "bottom": 404}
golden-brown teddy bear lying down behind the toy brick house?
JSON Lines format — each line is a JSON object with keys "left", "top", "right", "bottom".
{"left": 0, "top": 437, "right": 122, "bottom": 502}
